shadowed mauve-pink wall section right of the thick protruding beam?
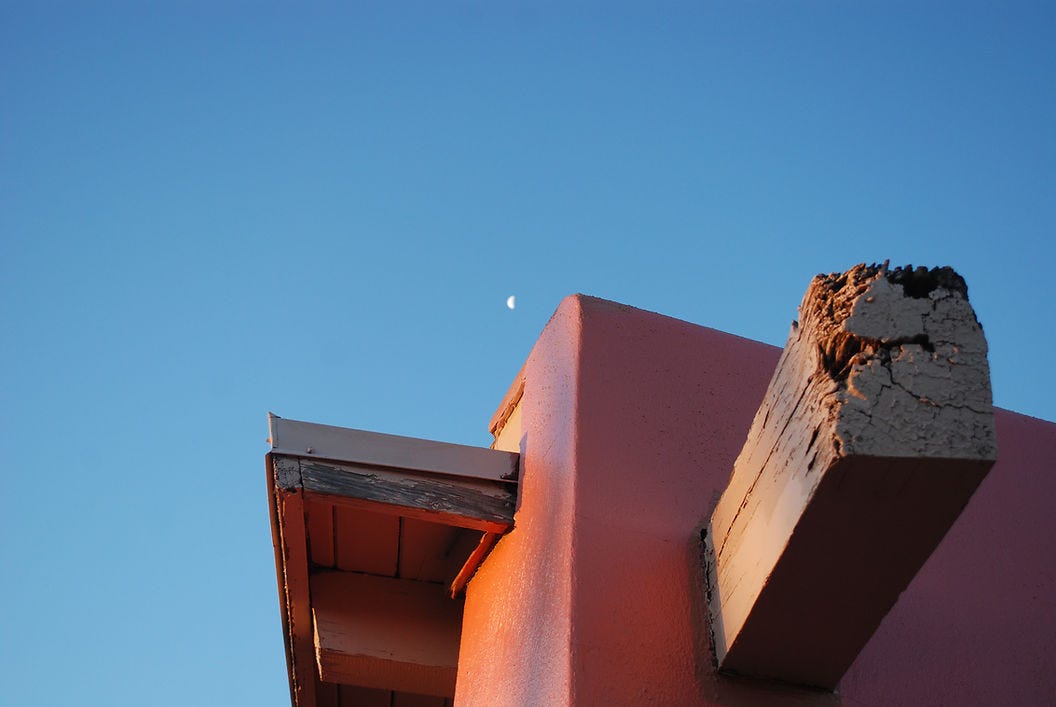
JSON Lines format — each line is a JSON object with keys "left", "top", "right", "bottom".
{"left": 840, "top": 409, "right": 1056, "bottom": 705}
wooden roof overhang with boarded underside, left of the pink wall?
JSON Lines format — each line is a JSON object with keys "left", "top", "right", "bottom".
{"left": 266, "top": 415, "right": 520, "bottom": 705}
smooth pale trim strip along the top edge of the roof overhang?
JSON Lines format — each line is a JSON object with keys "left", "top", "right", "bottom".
{"left": 268, "top": 414, "right": 517, "bottom": 481}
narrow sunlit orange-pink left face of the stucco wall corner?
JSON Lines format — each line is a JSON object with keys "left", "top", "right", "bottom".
{"left": 455, "top": 300, "right": 580, "bottom": 707}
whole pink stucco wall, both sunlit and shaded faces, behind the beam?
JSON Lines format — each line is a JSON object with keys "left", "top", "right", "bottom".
{"left": 456, "top": 295, "right": 1056, "bottom": 705}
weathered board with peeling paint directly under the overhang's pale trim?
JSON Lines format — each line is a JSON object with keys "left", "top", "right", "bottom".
{"left": 300, "top": 459, "right": 516, "bottom": 533}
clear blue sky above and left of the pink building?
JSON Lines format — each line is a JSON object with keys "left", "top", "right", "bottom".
{"left": 0, "top": 0, "right": 1056, "bottom": 706}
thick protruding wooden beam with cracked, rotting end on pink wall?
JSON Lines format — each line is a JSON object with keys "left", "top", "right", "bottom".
{"left": 705, "top": 265, "right": 997, "bottom": 689}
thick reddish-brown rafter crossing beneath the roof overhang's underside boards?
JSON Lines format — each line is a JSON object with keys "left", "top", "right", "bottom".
{"left": 312, "top": 572, "right": 463, "bottom": 698}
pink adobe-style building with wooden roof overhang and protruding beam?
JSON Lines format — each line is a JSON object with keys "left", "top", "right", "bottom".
{"left": 267, "top": 266, "right": 1056, "bottom": 707}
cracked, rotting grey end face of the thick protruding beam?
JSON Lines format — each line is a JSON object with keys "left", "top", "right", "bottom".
{"left": 790, "top": 265, "right": 997, "bottom": 459}
